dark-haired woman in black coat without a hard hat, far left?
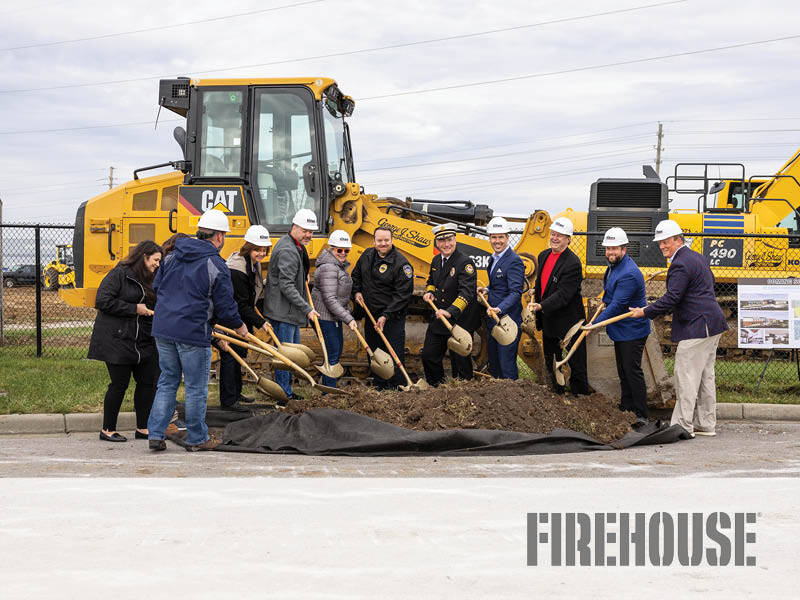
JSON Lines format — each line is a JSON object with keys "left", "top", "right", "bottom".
{"left": 88, "top": 240, "right": 162, "bottom": 442}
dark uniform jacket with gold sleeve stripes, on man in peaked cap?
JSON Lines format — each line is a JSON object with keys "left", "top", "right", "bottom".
{"left": 425, "top": 249, "right": 480, "bottom": 335}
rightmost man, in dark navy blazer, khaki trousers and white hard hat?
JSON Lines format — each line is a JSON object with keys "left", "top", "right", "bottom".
{"left": 631, "top": 220, "right": 728, "bottom": 437}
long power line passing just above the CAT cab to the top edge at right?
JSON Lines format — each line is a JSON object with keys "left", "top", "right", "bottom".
{"left": 0, "top": 0, "right": 688, "bottom": 94}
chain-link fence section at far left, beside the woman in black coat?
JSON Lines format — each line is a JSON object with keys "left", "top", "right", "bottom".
{"left": 0, "top": 224, "right": 95, "bottom": 358}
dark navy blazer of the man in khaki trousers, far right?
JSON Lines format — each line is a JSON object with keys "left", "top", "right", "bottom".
{"left": 644, "top": 246, "right": 728, "bottom": 342}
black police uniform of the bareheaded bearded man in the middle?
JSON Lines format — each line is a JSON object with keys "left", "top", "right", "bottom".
{"left": 351, "top": 247, "right": 414, "bottom": 389}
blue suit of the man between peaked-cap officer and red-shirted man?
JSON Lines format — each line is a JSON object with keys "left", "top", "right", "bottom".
{"left": 485, "top": 248, "right": 525, "bottom": 379}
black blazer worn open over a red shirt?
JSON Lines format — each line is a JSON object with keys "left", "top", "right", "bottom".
{"left": 533, "top": 248, "right": 586, "bottom": 338}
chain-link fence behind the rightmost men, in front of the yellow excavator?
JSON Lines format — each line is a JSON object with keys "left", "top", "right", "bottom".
{"left": 570, "top": 232, "right": 800, "bottom": 392}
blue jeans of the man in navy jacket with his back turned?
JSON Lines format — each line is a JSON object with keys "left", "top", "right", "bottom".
{"left": 147, "top": 338, "right": 211, "bottom": 446}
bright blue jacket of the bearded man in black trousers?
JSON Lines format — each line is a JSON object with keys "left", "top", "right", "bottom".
{"left": 594, "top": 254, "right": 650, "bottom": 342}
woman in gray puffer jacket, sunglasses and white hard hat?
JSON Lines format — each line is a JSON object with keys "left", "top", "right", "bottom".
{"left": 311, "top": 229, "right": 358, "bottom": 387}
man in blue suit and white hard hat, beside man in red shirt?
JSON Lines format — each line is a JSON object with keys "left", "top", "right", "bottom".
{"left": 478, "top": 217, "right": 525, "bottom": 379}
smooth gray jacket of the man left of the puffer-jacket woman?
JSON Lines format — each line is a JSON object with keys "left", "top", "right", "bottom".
{"left": 263, "top": 234, "right": 311, "bottom": 327}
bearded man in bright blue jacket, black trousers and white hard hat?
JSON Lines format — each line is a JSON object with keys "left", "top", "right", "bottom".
{"left": 595, "top": 227, "right": 650, "bottom": 427}
